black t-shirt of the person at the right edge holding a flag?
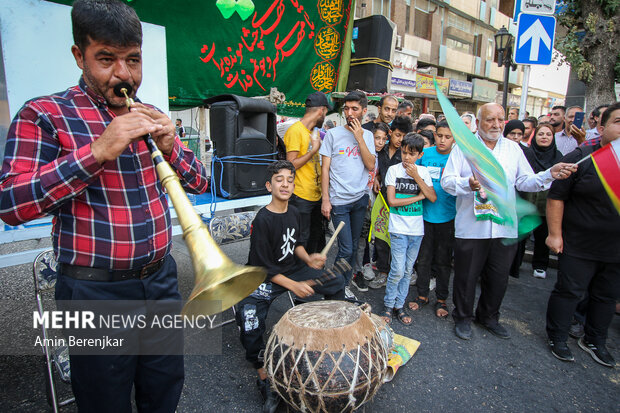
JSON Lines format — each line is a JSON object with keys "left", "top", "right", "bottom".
{"left": 548, "top": 145, "right": 620, "bottom": 263}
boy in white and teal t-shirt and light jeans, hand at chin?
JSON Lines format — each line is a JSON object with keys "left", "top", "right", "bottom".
{"left": 381, "top": 133, "right": 437, "bottom": 325}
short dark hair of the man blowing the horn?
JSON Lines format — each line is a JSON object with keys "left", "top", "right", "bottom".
{"left": 71, "top": 0, "right": 142, "bottom": 51}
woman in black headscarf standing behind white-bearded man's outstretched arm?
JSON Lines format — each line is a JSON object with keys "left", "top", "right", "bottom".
{"left": 524, "top": 123, "right": 562, "bottom": 278}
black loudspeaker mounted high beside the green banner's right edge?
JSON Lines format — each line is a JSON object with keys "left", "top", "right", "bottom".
{"left": 347, "top": 15, "right": 394, "bottom": 93}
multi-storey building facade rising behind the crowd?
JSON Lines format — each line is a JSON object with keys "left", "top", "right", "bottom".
{"left": 355, "top": 0, "right": 564, "bottom": 116}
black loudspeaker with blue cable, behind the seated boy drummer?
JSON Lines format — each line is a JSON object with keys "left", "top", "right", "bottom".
{"left": 205, "top": 95, "right": 277, "bottom": 199}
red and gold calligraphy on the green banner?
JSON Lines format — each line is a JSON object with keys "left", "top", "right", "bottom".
{"left": 199, "top": 0, "right": 348, "bottom": 107}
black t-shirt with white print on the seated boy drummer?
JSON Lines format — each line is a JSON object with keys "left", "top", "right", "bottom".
{"left": 248, "top": 204, "right": 302, "bottom": 282}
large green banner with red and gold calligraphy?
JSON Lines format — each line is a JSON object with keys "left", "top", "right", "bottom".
{"left": 53, "top": 0, "right": 353, "bottom": 116}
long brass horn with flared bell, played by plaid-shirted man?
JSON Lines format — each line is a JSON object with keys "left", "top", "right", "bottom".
{"left": 114, "top": 82, "right": 267, "bottom": 315}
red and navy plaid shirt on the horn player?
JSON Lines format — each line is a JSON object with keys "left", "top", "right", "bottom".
{"left": 0, "top": 79, "right": 208, "bottom": 269}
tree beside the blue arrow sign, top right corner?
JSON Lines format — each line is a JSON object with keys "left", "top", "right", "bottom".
{"left": 555, "top": 0, "right": 620, "bottom": 109}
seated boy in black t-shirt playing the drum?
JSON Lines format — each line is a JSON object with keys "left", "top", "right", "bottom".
{"left": 236, "top": 161, "right": 344, "bottom": 412}
